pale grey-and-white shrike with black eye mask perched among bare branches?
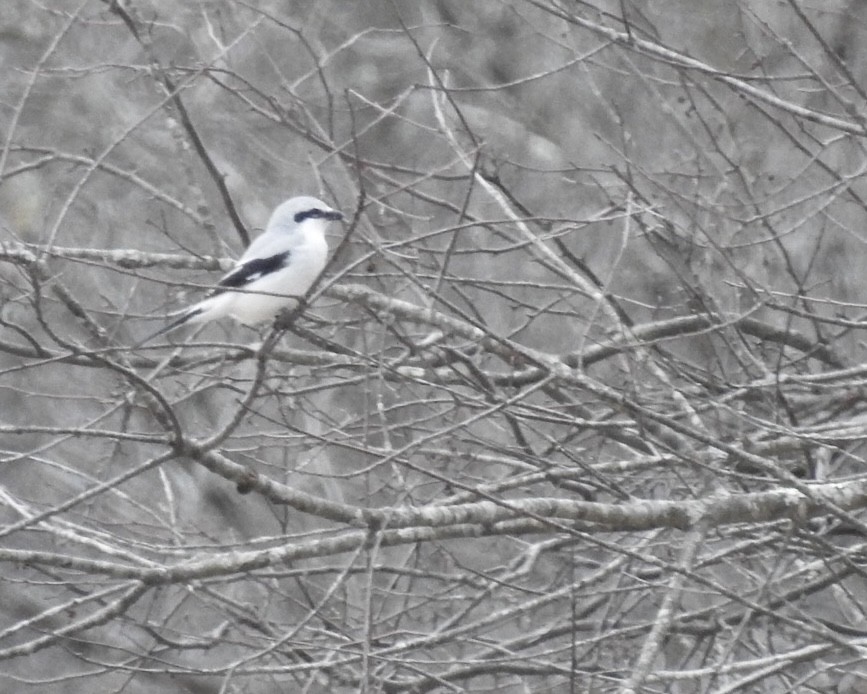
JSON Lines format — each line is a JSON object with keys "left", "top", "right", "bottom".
{"left": 136, "top": 195, "right": 343, "bottom": 347}
